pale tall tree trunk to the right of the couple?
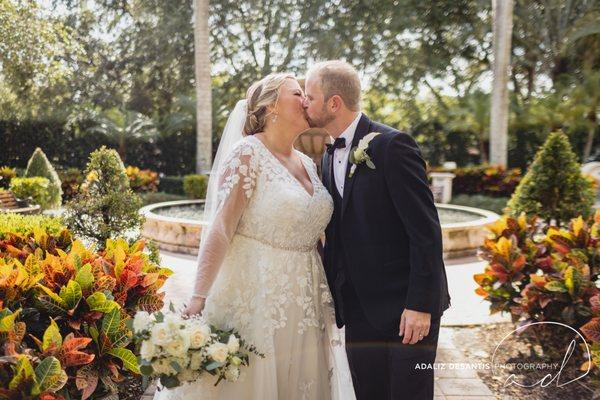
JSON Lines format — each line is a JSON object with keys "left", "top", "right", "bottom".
{"left": 490, "top": 0, "right": 514, "bottom": 167}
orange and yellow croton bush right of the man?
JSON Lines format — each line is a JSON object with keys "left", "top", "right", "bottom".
{"left": 474, "top": 211, "right": 600, "bottom": 328}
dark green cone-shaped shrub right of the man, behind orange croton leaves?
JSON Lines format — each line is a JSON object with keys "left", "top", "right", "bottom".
{"left": 508, "top": 131, "right": 594, "bottom": 225}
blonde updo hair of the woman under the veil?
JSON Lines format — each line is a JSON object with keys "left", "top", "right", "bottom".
{"left": 244, "top": 73, "right": 295, "bottom": 136}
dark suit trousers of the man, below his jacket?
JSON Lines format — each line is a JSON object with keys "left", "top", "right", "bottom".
{"left": 343, "top": 285, "right": 440, "bottom": 400}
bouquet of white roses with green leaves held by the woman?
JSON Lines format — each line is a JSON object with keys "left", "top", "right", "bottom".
{"left": 132, "top": 307, "right": 263, "bottom": 388}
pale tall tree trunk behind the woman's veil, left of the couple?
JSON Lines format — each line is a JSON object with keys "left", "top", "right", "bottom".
{"left": 194, "top": 0, "right": 212, "bottom": 174}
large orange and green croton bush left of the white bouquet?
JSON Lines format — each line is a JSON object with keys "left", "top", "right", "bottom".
{"left": 0, "top": 229, "right": 171, "bottom": 400}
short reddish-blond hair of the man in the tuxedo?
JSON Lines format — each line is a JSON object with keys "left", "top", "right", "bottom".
{"left": 307, "top": 60, "right": 361, "bottom": 111}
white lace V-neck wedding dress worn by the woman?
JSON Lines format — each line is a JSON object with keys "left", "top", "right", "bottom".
{"left": 155, "top": 136, "right": 354, "bottom": 400}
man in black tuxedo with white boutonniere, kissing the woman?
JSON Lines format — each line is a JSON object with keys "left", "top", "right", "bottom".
{"left": 304, "top": 61, "right": 450, "bottom": 400}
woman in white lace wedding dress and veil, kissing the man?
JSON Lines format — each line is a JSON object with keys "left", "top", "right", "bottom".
{"left": 155, "top": 73, "right": 354, "bottom": 400}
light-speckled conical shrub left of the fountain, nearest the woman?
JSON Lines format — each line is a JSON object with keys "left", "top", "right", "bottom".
{"left": 64, "top": 147, "right": 143, "bottom": 247}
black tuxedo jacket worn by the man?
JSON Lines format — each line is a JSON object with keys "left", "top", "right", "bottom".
{"left": 322, "top": 114, "right": 450, "bottom": 335}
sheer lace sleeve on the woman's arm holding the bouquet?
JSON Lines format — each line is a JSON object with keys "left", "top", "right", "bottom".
{"left": 194, "top": 141, "right": 258, "bottom": 297}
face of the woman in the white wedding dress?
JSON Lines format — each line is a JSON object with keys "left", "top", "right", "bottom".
{"left": 274, "top": 78, "right": 309, "bottom": 131}
